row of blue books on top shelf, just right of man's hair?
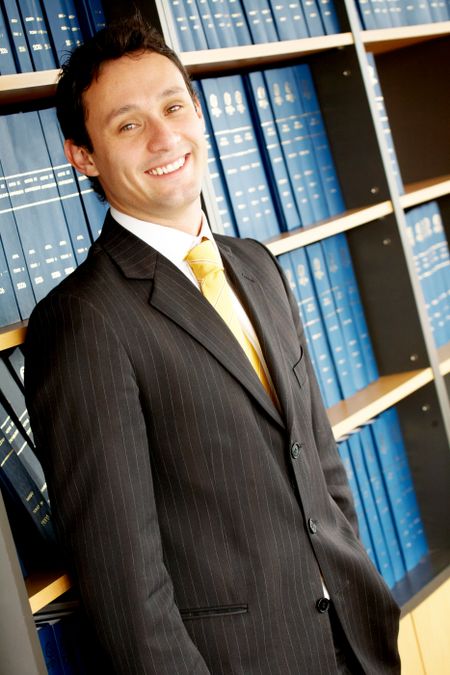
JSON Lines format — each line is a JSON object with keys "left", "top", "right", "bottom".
{"left": 168, "top": 0, "right": 340, "bottom": 51}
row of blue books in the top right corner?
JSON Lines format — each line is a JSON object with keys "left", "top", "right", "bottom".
{"left": 358, "top": 0, "right": 450, "bottom": 30}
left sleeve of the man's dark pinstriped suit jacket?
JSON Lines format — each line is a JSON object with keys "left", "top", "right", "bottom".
{"left": 25, "top": 294, "right": 209, "bottom": 675}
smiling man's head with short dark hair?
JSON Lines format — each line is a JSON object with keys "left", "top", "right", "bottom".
{"left": 57, "top": 18, "right": 206, "bottom": 231}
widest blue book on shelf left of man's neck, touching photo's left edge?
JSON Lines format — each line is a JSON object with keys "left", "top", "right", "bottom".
{"left": 0, "top": 112, "right": 76, "bottom": 300}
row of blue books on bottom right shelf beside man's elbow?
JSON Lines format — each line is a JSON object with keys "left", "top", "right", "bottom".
{"left": 338, "top": 408, "right": 428, "bottom": 588}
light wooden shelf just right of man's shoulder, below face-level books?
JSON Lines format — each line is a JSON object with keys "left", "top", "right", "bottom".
{"left": 264, "top": 201, "right": 392, "bottom": 255}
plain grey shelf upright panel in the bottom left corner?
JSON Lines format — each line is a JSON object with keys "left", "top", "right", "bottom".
{"left": 0, "top": 494, "right": 47, "bottom": 675}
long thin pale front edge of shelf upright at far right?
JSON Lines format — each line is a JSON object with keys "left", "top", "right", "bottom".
{"left": 344, "top": 0, "right": 450, "bottom": 446}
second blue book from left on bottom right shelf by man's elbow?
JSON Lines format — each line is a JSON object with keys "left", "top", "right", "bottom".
{"left": 347, "top": 433, "right": 395, "bottom": 588}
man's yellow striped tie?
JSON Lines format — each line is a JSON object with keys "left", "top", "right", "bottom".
{"left": 185, "top": 239, "right": 275, "bottom": 402}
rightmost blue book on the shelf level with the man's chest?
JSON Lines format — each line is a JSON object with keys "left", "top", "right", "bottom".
{"left": 320, "top": 235, "right": 370, "bottom": 391}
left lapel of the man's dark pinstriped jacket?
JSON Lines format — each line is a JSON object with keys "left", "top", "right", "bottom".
{"left": 98, "top": 216, "right": 284, "bottom": 426}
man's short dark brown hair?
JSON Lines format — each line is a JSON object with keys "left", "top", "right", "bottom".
{"left": 56, "top": 15, "right": 196, "bottom": 199}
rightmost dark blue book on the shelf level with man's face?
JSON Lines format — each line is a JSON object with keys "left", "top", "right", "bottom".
{"left": 295, "top": 64, "right": 345, "bottom": 216}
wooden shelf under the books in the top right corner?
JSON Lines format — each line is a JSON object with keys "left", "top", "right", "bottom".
{"left": 361, "top": 21, "right": 450, "bottom": 54}
